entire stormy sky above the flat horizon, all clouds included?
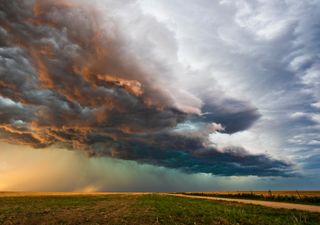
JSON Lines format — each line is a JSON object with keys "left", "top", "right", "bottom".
{"left": 0, "top": 0, "right": 320, "bottom": 191}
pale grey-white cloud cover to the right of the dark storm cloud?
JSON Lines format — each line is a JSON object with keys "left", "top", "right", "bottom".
{"left": 142, "top": 0, "right": 320, "bottom": 176}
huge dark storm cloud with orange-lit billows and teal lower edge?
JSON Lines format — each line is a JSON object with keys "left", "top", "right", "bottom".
{"left": 0, "top": 0, "right": 291, "bottom": 176}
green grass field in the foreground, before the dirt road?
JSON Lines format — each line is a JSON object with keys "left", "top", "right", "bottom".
{"left": 0, "top": 194, "right": 320, "bottom": 225}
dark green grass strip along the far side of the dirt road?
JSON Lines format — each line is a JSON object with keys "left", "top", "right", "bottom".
{"left": 181, "top": 192, "right": 320, "bottom": 205}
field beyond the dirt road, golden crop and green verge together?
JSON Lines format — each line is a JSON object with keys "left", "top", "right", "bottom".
{"left": 182, "top": 191, "right": 320, "bottom": 205}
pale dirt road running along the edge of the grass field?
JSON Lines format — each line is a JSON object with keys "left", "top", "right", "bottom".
{"left": 170, "top": 194, "right": 320, "bottom": 213}
